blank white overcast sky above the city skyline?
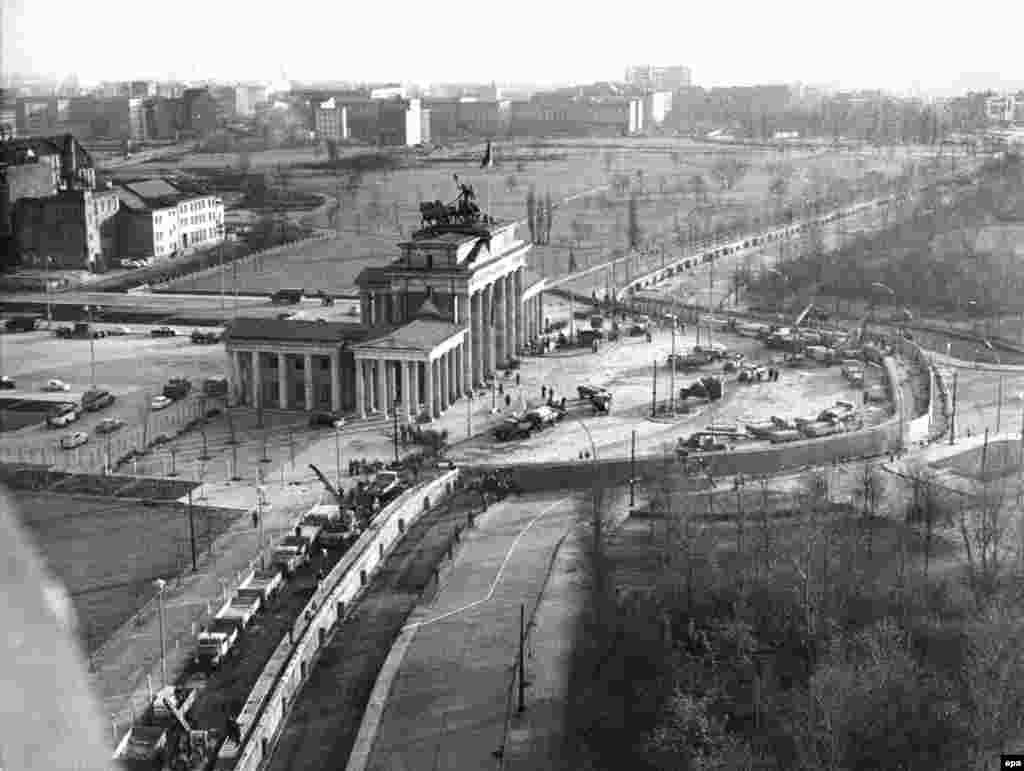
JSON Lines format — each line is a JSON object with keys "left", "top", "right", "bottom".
{"left": 0, "top": 0, "right": 1024, "bottom": 92}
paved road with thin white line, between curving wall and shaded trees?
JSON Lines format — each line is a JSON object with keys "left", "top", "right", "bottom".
{"left": 348, "top": 494, "right": 578, "bottom": 771}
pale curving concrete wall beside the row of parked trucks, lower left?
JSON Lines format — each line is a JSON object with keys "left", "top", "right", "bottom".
{"left": 216, "top": 470, "right": 459, "bottom": 771}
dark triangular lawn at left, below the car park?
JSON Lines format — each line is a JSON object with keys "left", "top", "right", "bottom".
{"left": 12, "top": 490, "right": 234, "bottom": 653}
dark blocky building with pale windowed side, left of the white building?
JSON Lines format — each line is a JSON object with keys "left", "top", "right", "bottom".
{"left": 13, "top": 189, "right": 120, "bottom": 272}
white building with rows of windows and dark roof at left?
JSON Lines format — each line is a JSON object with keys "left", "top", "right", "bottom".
{"left": 117, "top": 179, "right": 224, "bottom": 257}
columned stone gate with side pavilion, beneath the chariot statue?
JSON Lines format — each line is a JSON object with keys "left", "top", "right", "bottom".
{"left": 226, "top": 207, "right": 544, "bottom": 422}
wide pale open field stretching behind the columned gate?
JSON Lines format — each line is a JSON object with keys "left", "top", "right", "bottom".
{"left": 151, "top": 139, "right": 937, "bottom": 291}
